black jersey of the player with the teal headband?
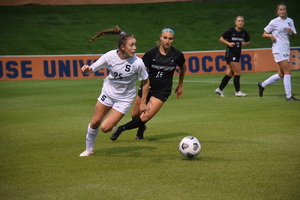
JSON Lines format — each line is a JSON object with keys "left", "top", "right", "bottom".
{"left": 143, "top": 46, "right": 185, "bottom": 93}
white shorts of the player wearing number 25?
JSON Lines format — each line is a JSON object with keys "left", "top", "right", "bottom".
{"left": 98, "top": 92, "right": 132, "bottom": 115}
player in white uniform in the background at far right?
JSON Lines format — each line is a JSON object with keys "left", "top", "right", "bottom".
{"left": 258, "top": 3, "right": 299, "bottom": 101}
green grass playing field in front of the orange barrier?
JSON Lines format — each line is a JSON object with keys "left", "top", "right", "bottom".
{"left": 0, "top": 71, "right": 300, "bottom": 200}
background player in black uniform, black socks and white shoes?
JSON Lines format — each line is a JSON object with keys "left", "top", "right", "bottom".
{"left": 215, "top": 16, "right": 250, "bottom": 97}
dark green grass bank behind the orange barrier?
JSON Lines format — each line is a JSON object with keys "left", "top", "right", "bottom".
{"left": 0, "top": 0, "right": 300, "bottom": 55}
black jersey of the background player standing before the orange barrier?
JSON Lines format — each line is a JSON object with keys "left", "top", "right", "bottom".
{"left": 222, "top": 28, "right": 250, "bottom": 57}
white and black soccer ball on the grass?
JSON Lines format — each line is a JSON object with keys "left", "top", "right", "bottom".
{"left": 179, "top": 136, "right": 201, "bottom": 158}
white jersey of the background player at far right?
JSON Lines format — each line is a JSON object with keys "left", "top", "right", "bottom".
{"left": 264, "top": 17, "right": 297, "bottom": 54}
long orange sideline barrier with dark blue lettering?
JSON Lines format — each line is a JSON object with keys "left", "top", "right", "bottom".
{"left": 0, "top": 47, "right": 300, "bottom": 81}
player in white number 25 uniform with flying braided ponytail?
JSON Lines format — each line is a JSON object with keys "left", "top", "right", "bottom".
{"left": 79, "top": 27, "right": 149, "bottom": 156}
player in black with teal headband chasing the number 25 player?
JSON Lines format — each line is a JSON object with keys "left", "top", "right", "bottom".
{"left": 110, "top": 27, "right": 185, "bottom": 140}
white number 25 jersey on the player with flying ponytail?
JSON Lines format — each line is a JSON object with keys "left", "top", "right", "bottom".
{"left": 91, "top": 50, "right": 148, "bottom": 101}
